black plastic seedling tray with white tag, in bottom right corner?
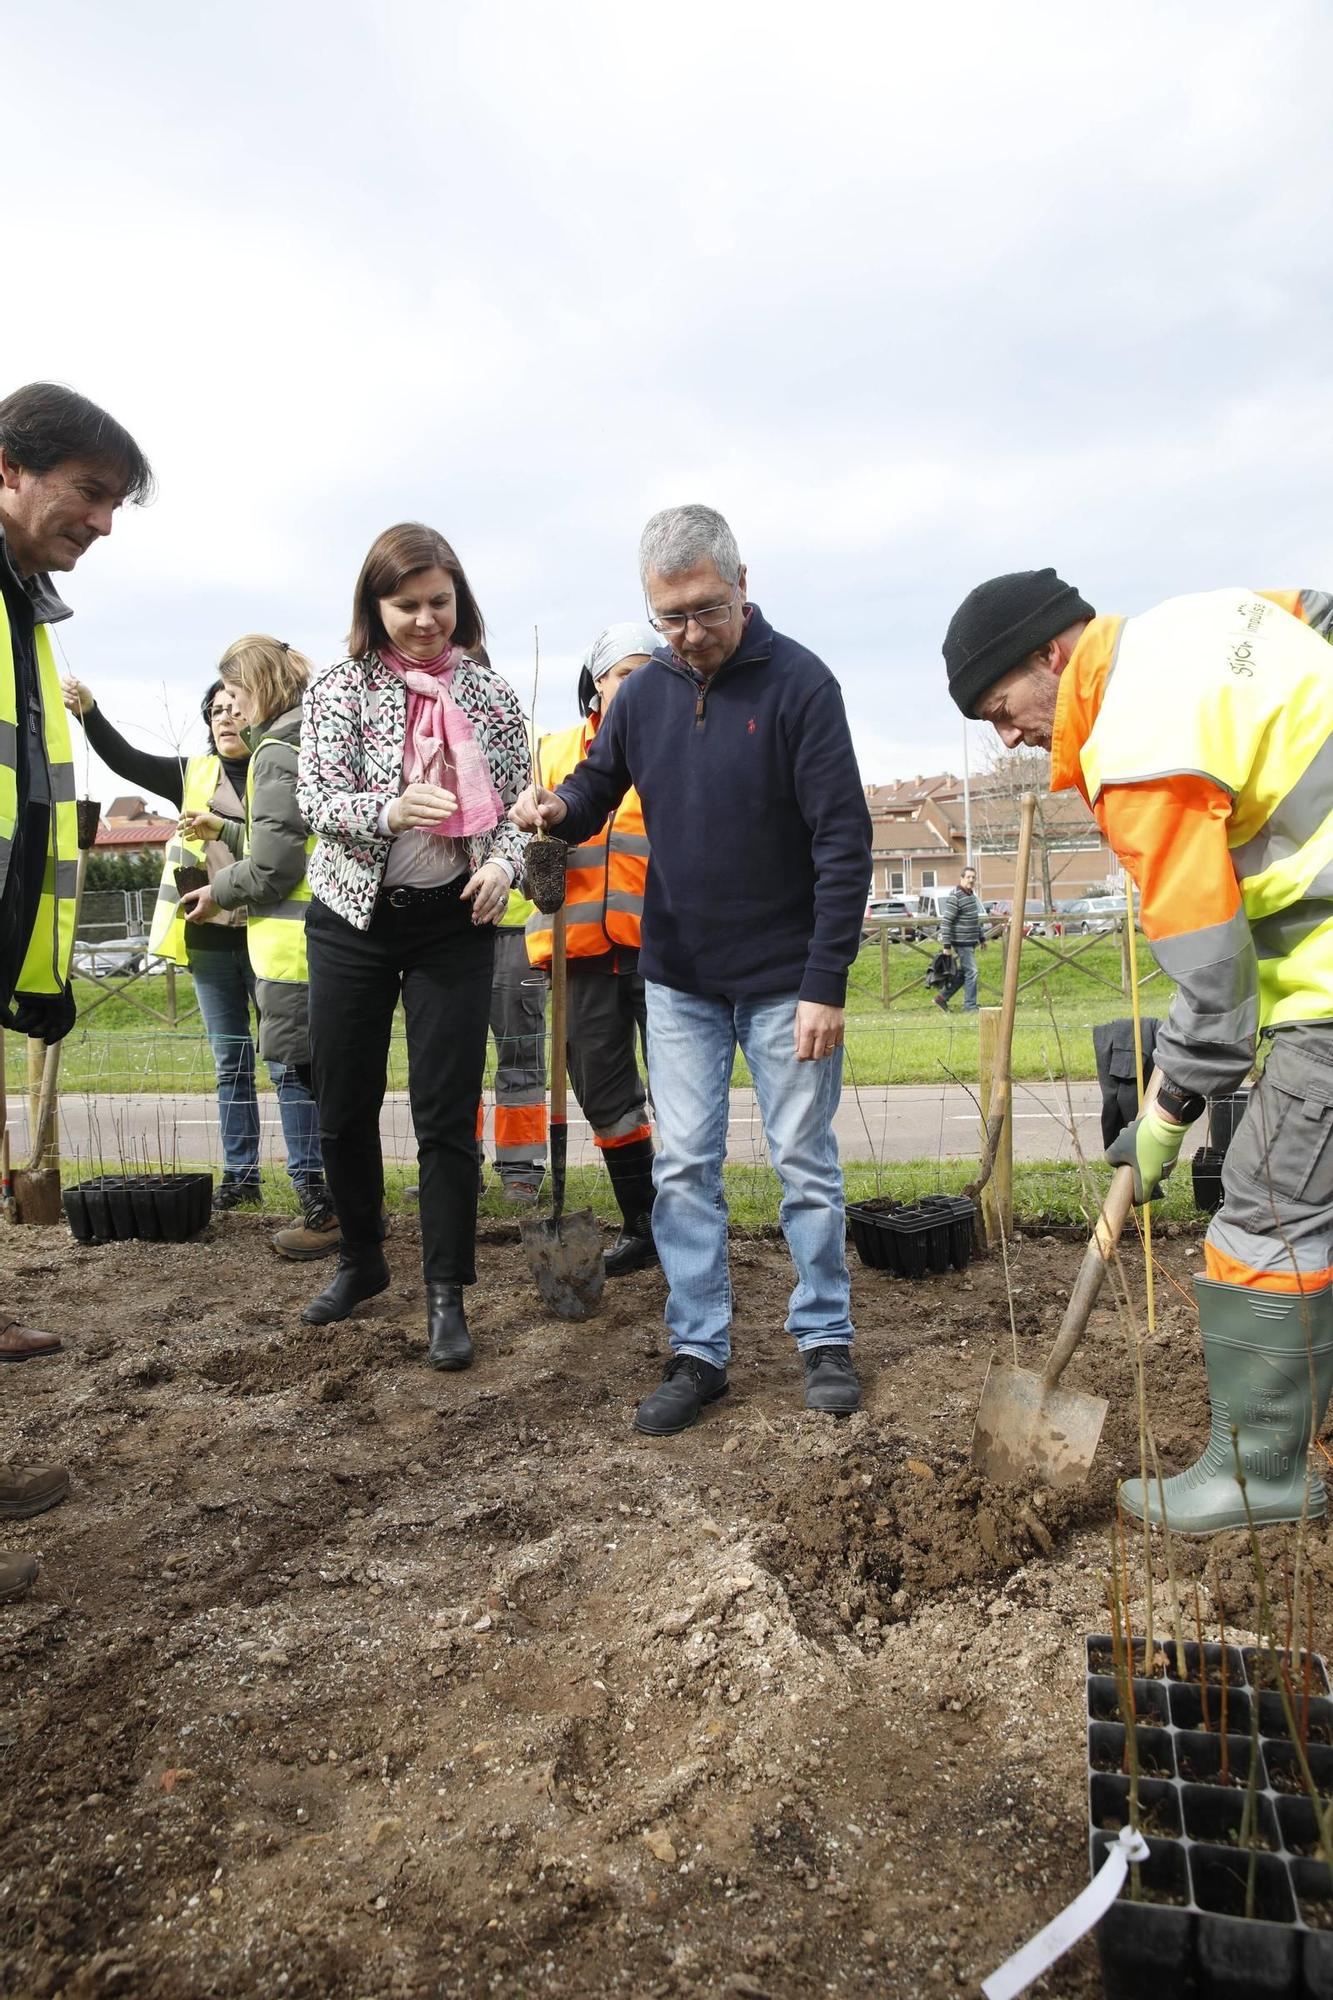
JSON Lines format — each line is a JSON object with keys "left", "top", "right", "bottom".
{"left": 1087, "top": 1634, "right": 1333, "bottom": 2000}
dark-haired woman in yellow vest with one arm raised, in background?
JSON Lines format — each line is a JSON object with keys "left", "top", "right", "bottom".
{"left": 64, "top": 678, "right": 320, "bottom": 1244}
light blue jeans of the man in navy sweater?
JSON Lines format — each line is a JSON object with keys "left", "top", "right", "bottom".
{"left": 646, "top": 982, "right": 853, "bottom": 1368}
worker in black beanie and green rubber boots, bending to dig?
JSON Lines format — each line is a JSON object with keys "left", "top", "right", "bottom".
{"left": 945, "top": 570, "right": 1333, "bottom": 1534}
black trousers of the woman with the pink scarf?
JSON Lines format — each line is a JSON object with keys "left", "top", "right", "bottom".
{"left": 306, "top": 876, "right": 494, "bottom": 1284}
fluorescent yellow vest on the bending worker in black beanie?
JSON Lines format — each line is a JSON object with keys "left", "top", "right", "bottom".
{"left": 1081, "top": 590, "right": 1333, "bottom": 1028}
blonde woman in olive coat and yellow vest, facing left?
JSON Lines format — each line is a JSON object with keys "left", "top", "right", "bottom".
{"left": 180, "top": 634, "right": 338, "bottom": 1262}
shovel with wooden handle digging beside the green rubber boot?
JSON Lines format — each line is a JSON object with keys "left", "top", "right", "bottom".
{"left": 973, "top": 1076, "right": 1161, "bottom": 1486}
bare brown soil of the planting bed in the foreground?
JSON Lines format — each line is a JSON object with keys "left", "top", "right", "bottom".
{"left": 0, "top": 1216, "right": 1333, "bottom": 2000}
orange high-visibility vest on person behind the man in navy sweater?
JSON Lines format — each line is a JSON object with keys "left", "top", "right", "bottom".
{"left": 526, "top": 714, "right": 648, "bottom": 966}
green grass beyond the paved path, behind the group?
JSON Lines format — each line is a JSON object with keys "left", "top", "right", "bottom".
{"left": 6, "top": 938, "right": 1175, "bottom": 1092}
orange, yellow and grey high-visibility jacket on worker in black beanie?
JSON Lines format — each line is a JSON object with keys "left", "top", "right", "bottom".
{"left": 1051, "top": 590, "right": 1333, "bottom": 1096}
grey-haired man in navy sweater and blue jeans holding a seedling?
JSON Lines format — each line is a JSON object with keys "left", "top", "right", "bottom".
{"left": 512, "top": 506, "right": 871, "bottom": 1436}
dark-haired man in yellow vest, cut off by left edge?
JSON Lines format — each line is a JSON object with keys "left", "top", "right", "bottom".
{"left": 0, "top": 382, "right": 152, "bottom": 1600}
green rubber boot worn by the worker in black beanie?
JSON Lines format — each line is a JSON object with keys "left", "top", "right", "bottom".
{"left": 1121, "top": 1278, "right": 1333, "bottom": 1534}
